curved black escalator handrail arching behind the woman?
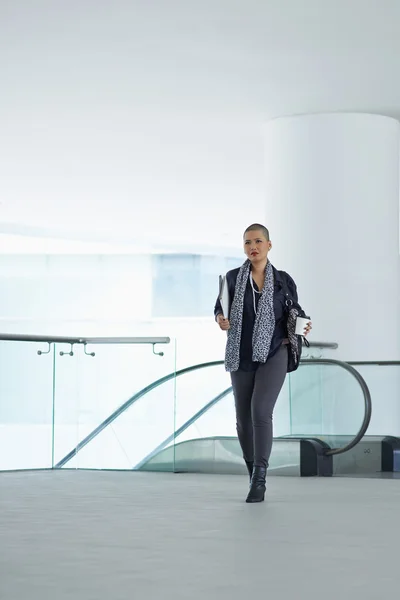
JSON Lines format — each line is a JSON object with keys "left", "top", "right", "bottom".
{"left": 54, "top": 358, "right": 372, "bottom": 469}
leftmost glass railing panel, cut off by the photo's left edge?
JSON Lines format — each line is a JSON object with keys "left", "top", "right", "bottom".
{"left": 0, "top": 341, "right": 53, "bottom": 470}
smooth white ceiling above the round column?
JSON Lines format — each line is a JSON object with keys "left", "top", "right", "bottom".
{"left": 0, "top": 0, "right": 400, "bottom": 248}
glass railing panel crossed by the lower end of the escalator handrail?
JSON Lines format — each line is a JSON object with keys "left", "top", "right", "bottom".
{"left": 55, "top": 340, "right": 176, "bottom": 470}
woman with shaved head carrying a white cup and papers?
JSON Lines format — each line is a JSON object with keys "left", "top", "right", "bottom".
{"left": 214, "top": 223, "right": 311, "bottom": 502}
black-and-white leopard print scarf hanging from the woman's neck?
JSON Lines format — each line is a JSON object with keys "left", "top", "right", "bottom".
{"left": 225, "top": 260, "right": 275, "bottom": 372}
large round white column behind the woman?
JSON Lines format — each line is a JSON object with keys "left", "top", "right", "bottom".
{"left": 265, "top": 113, "right": 400, "bottom": 360}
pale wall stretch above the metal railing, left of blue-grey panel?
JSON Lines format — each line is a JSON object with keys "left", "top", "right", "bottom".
{"left": 0, "top": 255, "right": 152, "bottom": 328}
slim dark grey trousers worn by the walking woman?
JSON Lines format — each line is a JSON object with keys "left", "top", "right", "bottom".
{"left": 231, "top": 345, "right": 288, "bottom": 468}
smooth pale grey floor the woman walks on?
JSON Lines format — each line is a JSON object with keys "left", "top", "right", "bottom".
{"left": 0, "top": 471, "right": 400, "bottom": 600}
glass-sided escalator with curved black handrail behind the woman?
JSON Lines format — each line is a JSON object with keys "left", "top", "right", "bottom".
{"left": 55, "top": 358, "right": 400, "bottom": 476}
